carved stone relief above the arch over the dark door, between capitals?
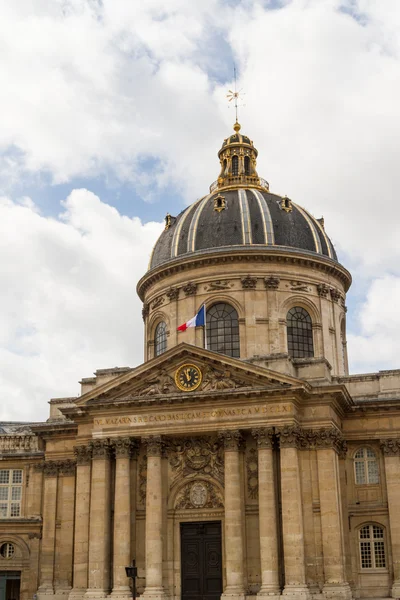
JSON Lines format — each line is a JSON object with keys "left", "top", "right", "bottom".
{"left": 168, "top": 437, "right": 224, "bottom": 485}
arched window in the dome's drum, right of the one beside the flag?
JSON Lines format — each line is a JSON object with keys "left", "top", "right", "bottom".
{"left": 286, "top": 306, "right": 314, "bottom": 358}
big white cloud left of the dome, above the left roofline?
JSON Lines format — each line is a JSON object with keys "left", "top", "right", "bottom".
{"left": 0, "top": 189, "right": 163, "bottom": 420}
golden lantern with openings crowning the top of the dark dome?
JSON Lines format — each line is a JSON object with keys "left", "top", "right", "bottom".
{"left": 210, "top": 121, "right": 269, "bottom": 192}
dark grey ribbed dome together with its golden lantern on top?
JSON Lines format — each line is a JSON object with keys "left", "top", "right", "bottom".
{"left": 149, "top": 122, "right": 337, "bottom": 269}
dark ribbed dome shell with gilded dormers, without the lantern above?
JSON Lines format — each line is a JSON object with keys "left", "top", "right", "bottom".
{"left": 150, "top": 187, "right": 337, "bottom": 269}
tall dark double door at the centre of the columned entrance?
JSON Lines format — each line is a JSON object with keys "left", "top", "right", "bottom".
{"left": 181, "top": 521, "right": 222, "bottom": 600}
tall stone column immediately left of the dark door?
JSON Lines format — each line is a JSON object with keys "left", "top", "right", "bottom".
{"left": 143, "top": 436, "right": 167, "bottom": 600}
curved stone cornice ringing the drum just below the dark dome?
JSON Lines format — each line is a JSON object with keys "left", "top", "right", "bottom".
{"left": 136, "top": 246, "right": 352, "bottom": 302}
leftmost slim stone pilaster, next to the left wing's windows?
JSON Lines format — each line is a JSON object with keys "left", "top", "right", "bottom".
{"left": 38, "top": 461, "right": 58, "bottom": 599}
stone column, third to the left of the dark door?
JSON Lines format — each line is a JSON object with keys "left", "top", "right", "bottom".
{"left": 85, "top": 440, "right": 111, "bottom": 599}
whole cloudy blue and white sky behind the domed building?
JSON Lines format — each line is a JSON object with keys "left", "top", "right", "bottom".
{"left": 0, "top": 0, "right": 400, "bottom": 421}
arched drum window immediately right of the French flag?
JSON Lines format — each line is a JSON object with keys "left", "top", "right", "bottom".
{"left": 207, "top": 302, "right": 240, "bottom": 358}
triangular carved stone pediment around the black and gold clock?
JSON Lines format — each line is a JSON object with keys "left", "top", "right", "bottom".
{"left": 76, "top": 343, "right": 308, "bottom": 406}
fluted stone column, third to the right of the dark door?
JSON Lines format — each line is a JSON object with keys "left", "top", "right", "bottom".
{"left": 278, "top": 426, "right": 310, "bottom": 598}
